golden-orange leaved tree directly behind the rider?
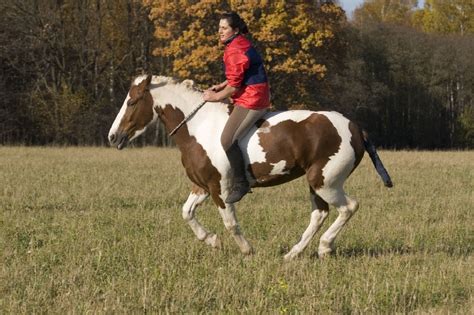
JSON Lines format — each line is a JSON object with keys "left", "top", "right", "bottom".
{"left": 145, "top": 0, "right": 345, "bottom": 107}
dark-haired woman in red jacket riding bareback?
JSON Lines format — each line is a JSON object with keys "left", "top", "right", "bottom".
{"left": 204, "top": 12, "right": 270, "bottom": 203}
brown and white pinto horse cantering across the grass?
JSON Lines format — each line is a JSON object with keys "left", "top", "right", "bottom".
{"left": 108, "top": 75, "right": 392, "bottom": 260}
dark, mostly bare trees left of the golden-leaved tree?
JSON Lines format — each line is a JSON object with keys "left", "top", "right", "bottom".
{"left": 0, "top": 0, "right": 157, "bottom": 144}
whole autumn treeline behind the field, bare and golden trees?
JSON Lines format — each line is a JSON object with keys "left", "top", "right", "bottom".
{"left": 0, "top": 0, "right": 474, "bottom": 149}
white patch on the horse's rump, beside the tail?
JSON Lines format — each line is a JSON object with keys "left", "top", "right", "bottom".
{"left": 318, "top": 112, "right": 355, "bottom": 187}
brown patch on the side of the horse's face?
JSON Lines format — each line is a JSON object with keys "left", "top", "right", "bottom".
{"left": 119, "top": 76, "right": 153, "bottom": 137}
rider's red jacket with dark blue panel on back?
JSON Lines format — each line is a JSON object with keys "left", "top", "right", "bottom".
{"left": 224, "top": 35, "right": 270, "bottom": 109}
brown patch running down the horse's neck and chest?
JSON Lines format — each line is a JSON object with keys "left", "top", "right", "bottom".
{"left": 156, "top": 104, "right": 225, "bottom": 209}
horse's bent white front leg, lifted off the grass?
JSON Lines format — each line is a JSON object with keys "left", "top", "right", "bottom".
{"left": 183, "top": 186, "right": 220, "bottom": 248}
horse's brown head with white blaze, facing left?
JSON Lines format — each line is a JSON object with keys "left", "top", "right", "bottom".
{"left": 109, "top": 75, "right": 157, "bottom": 150}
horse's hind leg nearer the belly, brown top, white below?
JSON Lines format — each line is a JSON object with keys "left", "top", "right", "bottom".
{"left": 285, "top": 187, "right": 329, "bottom": 260}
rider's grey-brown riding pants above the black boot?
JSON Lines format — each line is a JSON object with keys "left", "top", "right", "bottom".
{"left": 221, "top": 105, "right": 267, "bottom": 151}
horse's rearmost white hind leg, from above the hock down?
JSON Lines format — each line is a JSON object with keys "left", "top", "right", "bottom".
{"left": 317, "top": 187, "right": 359, "bottom": 258}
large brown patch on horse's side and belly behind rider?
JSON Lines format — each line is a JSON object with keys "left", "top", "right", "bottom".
{"left": 249, "top": 113, "right": 342, "bottom": 189}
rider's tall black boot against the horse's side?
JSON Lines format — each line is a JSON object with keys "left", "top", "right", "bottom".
{"left": 225, "top": 142, "right": 250, "bottom": 203}
